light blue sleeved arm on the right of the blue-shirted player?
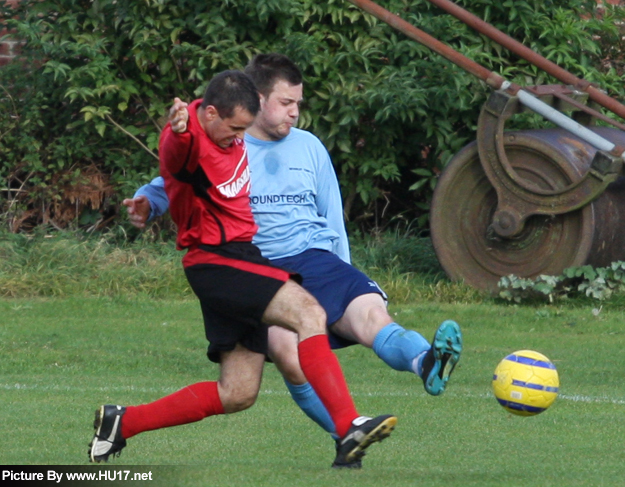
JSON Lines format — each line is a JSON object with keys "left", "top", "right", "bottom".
{"left": 316, "top": 148, "right": 351, "bottom": 264}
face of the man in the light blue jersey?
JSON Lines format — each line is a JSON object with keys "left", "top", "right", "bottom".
{"left": 254, "top": 80, "right": 303, "bottom": 140}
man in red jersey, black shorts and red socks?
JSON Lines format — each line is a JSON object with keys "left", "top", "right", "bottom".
{"left": 89, "top": 71, "right": 397, "bottom": 463}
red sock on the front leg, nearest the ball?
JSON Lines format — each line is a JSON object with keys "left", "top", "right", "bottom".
{"left": 298, "top": 335, "right": 358, "bottom": 438}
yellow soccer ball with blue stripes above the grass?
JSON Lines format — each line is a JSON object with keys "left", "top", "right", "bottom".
{"left": 493, "top": 350, "right": 560, "bottom": 416}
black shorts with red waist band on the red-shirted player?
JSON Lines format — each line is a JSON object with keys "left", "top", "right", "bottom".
{"left": 183, "top": 242, "right": 300, "bottom": 362}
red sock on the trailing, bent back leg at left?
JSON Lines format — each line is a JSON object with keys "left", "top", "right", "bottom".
{"left": 122, "top": 382, "right": 224, "bottom": 439}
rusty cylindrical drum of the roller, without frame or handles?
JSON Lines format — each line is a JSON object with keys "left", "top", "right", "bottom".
{"left": 431, "top": 128, "right": 625, "bottom": 291}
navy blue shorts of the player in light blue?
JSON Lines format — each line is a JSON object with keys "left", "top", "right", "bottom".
{"left": 271, "top": 249, "right": 386, "bottom": 348}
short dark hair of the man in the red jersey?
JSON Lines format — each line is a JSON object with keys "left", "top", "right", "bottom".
{"left": 202, "top": 69, "right": 260, "bottom": 118}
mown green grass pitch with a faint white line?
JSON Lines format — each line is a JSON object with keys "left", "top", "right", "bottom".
{"left": 0, "top": 297, "right": 625, "bottom": 487}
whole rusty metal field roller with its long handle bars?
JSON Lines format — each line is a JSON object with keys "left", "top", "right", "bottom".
{"left": 349, "top": 0, "right": 625, "bottom": 291}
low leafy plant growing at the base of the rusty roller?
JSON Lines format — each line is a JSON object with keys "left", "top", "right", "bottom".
{"left": 498, "top": 261, "right": 625, "bottom": 303}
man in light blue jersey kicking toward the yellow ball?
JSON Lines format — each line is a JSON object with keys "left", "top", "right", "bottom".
{"left": 124, "top": 54, "right": 462, "bottom": 468}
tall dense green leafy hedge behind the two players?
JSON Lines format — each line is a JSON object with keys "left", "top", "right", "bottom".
{"left": 0, "top": 0, "right": 624, "bottom": 231}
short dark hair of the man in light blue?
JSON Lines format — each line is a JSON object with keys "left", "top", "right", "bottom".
{"left": 245, "top": 53, "right": 302, "bottom": 97}
